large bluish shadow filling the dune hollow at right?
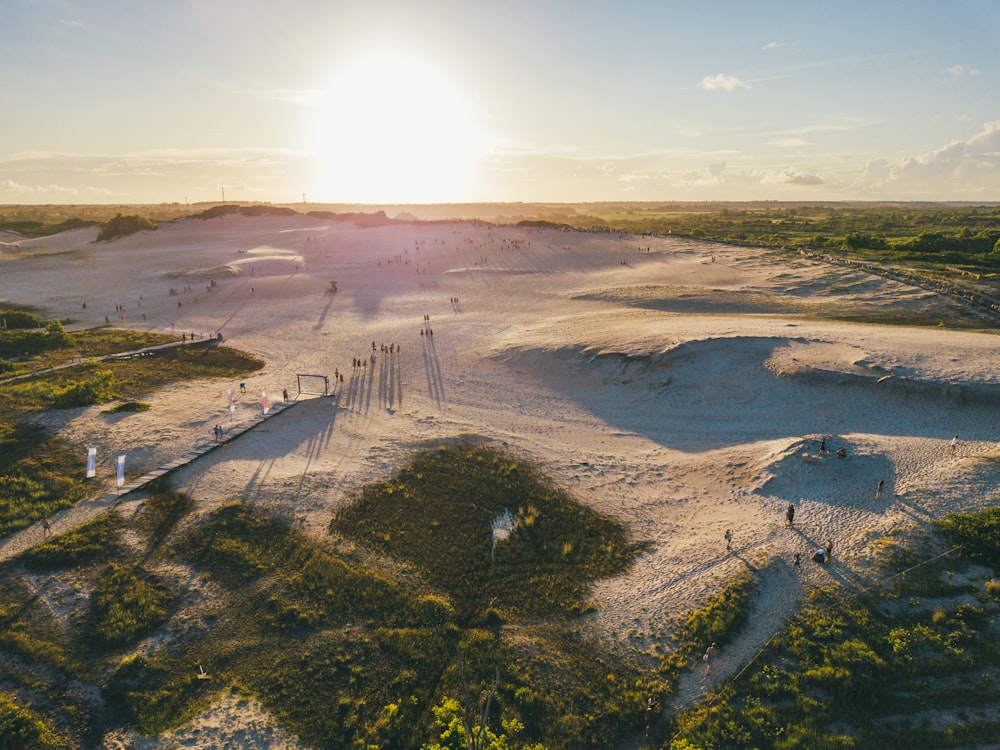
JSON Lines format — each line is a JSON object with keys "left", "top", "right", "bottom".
{"left": 516, "top": 337, "right": 1000, "bottom": 452}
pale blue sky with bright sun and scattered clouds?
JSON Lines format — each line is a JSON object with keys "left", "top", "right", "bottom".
{"left": 0, "top": 0, "right": 1000, "bottom": 204}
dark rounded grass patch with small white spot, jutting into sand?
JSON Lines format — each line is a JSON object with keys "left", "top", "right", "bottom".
{"left": 331, "top": 440, "right": 639, "bottom": 623}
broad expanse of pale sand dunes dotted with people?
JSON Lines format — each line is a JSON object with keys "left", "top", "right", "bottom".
{"left": 0, "top": 217, "right": 1000, "bottom": 748}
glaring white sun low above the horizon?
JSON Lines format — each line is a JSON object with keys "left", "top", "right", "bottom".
{"left": 314, "top": 51, "right": 484, "bottom": 203}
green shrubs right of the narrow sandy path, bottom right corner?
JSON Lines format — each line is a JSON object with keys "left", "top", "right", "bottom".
{"left": 667, "top": 532, "right": 1000, "bottom": 750}
